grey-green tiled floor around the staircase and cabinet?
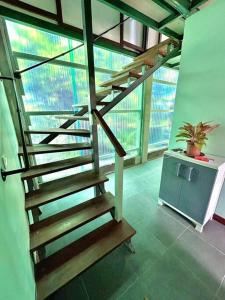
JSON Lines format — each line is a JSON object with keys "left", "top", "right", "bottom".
{"left": 43, "top": 159, "right": 225, "bottom": 300}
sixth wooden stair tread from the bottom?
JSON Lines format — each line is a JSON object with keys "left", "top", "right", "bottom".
{"left": 24, "top": 128, "right": 90, "bottom": 137}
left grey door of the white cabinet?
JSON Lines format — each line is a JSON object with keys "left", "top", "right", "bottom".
{"left": 159, "top": 155, "right": 182, "bottom": 208}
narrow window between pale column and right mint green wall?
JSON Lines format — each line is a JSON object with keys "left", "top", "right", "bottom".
{"left": 149, "top": 67, "right": 178, "bottom": 151}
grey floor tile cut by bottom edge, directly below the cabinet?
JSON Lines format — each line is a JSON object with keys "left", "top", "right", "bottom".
{"left": 142, "top": 252, "right": 214, "bottom": 300}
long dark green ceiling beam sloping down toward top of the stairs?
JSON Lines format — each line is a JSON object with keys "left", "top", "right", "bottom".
{"left": 98, "top": 0, "right": 182, "bottom": 40}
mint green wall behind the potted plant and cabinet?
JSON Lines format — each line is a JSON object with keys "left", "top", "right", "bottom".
{"left": 170, "top": 0, "right": 225, "bottom": 217}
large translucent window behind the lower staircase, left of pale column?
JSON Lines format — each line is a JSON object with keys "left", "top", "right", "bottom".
{"left": 7, "top": 21, "right": 142, "bottom": 171}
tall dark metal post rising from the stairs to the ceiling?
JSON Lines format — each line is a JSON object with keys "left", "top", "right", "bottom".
{"left": 81, "top": 0, "right": 100, "bottom": 195}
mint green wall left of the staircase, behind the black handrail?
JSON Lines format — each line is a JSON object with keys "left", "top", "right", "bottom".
{"left": 0, "top": 82, "right": 35, "bottom": 300}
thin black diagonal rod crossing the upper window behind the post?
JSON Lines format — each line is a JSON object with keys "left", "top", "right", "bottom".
{"left": 14, "top": 17, "right": 130, "bottom": 79}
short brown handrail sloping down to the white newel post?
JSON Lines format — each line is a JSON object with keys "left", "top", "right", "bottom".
{"left": 92, "top": 109, "right": 127, "bottom": 157}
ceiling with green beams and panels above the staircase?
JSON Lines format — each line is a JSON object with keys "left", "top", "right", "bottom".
{"left": 0, "top": 0, "right": 213, "bottom": 67}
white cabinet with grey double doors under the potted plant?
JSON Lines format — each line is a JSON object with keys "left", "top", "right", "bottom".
{"left": 159, "top": 151, "right": 225, "bottom": 232}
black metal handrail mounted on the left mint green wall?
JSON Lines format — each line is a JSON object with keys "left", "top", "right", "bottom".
{"left": 0, "top": 76, "right": 30, "bottom": 181}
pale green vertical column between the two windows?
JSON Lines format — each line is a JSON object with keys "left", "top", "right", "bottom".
{"left": 140, "top": 67, "right": 153, "bottom": 163}
